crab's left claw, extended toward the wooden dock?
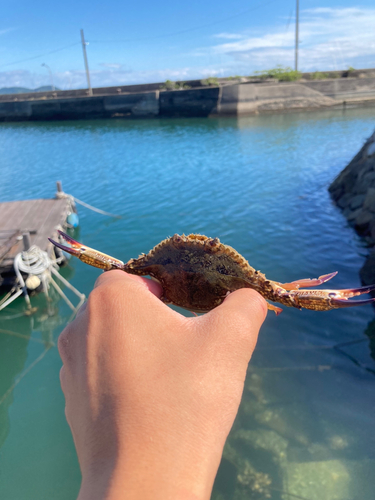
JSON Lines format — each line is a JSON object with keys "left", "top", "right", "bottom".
{"left": 48, "top": 231, "right": 124, "bottom": 271}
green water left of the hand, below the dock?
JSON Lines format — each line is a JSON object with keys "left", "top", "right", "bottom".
{"left": 0, "top": 266, "right": 80, "bottom": 500}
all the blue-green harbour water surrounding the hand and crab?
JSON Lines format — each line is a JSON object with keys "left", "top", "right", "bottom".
{"left": 0, "top": 108, "right": 375, "bottom": 500}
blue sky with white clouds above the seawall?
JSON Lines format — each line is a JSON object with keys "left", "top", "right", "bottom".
{"left": 0, "top": 0, "right": 375, "bottom": 89}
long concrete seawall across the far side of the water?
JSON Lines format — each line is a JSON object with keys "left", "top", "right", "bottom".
{"left": 0, "top": 77, "right": 375, "bottom": 121}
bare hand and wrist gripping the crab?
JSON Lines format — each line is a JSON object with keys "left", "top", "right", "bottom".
{"left": 58, "top": 271, "right": 267, "bottom": 500}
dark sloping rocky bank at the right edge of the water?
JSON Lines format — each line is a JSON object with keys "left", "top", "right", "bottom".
{"left": 329, "top": 132, "right": 375, "bottom": 285}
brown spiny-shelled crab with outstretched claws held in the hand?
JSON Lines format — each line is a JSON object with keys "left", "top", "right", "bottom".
{"left": 49, "top": 231, "right": 375, "bottom": 314}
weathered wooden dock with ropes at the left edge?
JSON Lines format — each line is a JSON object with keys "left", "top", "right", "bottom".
{"left": 0, "top": 198, "right": 70, "bottom": 287}
